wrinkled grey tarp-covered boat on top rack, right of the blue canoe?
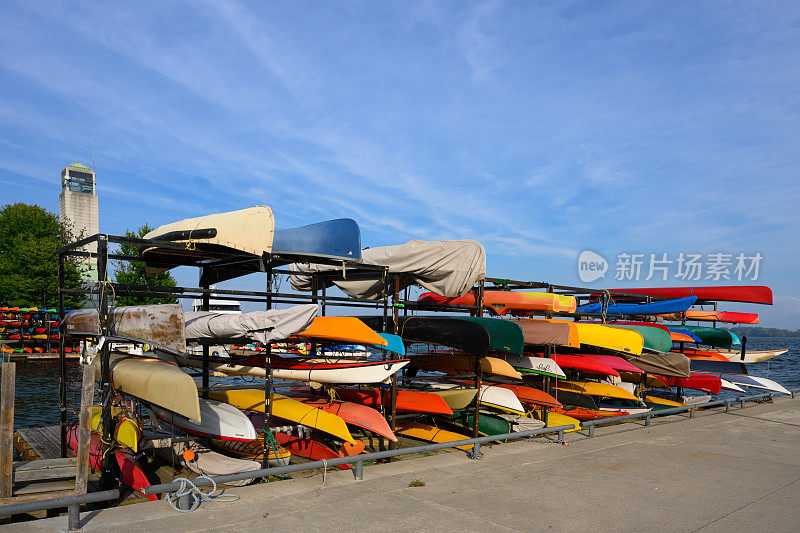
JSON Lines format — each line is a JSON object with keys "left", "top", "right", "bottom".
{"left": 289, "top": 239, "right": 486, "bottom": 300}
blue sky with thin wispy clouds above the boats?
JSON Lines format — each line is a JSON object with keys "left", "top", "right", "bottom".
{"left": 0, "top": 1, "right": 800, "bottom": 329}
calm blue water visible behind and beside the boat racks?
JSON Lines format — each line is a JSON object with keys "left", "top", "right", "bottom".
{"left": 1, "top": 337, "right": 800, "bottom": 428}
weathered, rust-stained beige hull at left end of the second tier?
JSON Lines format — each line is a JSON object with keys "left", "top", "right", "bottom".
{"left": 64, "top": 304, "right": 186, "bottom": 352}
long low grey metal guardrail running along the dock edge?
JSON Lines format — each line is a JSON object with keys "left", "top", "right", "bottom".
{"left": 0, "top": 388, "right": 800, "bottom": 531}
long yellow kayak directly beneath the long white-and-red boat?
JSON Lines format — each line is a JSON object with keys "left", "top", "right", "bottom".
{"left": 208, "top": 389, "right": 356, "bottom": 444}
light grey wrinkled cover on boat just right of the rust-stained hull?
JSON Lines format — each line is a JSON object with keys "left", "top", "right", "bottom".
{"left": 186, "top": 304, "right": 317, "bottom": 344}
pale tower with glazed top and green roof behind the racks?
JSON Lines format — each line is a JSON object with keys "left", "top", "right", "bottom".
{"left": 58, "top": 162, "right": 100, "bottom": 281}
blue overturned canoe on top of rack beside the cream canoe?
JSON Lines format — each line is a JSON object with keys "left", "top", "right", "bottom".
{"left": 272, "top": 218, "right": 361, "bottom": 259}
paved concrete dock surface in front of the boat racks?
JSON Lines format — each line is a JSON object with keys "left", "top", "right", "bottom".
{"left": 7, "top": 398, "right": 800, "bottom": 533}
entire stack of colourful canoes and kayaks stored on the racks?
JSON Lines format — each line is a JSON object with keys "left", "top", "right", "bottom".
{"left": 54, "top": 208, "right": 787, "bottom": 500}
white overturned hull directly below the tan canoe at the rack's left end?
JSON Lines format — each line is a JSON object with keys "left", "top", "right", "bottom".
{"left": 151, "top": 398, "right": 258, "bottom": 442}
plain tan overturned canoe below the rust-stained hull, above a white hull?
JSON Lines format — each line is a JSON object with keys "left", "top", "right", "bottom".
{"left": 92, "top": 353, "right": 202, "bottom": 422}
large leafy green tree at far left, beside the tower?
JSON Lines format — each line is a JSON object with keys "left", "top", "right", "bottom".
{"left": 0, "top": 202, "right": 83, "bottom": 308}
